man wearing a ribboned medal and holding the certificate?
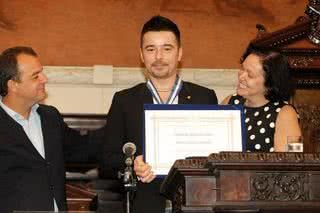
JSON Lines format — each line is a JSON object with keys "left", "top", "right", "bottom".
{"left": 100, "top": 16, "right": 217, "bottom": 213}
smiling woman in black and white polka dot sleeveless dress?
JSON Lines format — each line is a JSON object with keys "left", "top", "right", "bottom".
{"left": 222, "top": 47, "right": 301, "bottom": 152}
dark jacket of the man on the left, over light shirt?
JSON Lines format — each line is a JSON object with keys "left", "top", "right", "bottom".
{"left": 0, "top": 105, "right": 86, "bottom": 213}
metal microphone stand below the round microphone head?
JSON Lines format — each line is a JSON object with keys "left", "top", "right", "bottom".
{"left": 119, "top": 157, "right": 137, "bottom": 213}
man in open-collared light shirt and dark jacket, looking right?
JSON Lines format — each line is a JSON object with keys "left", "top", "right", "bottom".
{"left": 0, "top": 47, "right": 86, "bottom": 213}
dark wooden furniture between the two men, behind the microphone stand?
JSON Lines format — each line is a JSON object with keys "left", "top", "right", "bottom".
{"left": 62, "top": 113, "right": 123, "bottom": 213}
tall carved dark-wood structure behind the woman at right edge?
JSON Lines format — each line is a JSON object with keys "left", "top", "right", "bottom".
{"left": 251, "top": 0, "right": 320, "bottom": 152}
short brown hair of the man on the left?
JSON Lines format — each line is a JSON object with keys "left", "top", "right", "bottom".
{"left": 0, "top": 46, "right": 38, "bottom": 97}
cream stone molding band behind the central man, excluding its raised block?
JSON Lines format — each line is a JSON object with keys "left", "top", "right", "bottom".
{"left": 44, "top": 66, "right": 237, "bottom": 87}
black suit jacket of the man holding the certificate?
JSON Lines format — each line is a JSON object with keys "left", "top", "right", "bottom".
{"left": 100, "top": 82, "right": 218, "bottom": 213}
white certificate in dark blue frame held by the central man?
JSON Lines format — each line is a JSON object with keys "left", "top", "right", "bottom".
{"left": 143, "top": 104, "right": 245, "bottom": 176}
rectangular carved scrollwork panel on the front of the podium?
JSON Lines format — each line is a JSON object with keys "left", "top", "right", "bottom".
{"left": 251, "top": 173, "right": 309, "bottom": 201}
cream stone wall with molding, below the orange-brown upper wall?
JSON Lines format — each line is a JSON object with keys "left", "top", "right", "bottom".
{"left": 44, "top": 65, "right": 237, "bottom": 113}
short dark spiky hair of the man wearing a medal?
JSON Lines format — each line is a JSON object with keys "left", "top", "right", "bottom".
{"left": 140, "top": 15, "right": 181, "bottom": 47}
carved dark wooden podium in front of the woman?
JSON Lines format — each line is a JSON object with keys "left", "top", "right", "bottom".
{"left": 161, "top": 152, "right": 320, "bottom": 213}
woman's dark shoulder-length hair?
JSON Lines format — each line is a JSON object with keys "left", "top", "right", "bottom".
{"left": 240, "top": 45, "right": 294, "bottom": 102}
